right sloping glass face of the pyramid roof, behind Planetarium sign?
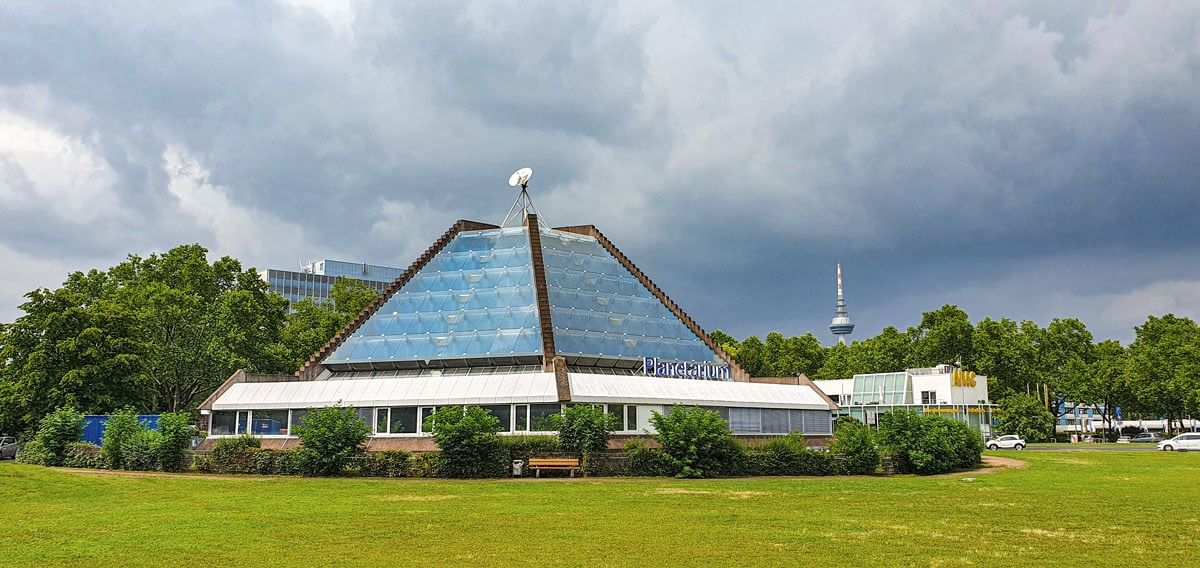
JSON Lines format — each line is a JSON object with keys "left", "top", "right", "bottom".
{"left": 541, "top": 231, "right": 724, "bottom": 364}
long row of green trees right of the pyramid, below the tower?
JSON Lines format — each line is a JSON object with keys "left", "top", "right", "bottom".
{"left": 712, "top": 305, "right": 1200, "bottom": 431}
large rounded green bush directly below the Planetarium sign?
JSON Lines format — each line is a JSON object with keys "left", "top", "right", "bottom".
{"left": 650, "top": 405, "right": 740, "bottom": 478}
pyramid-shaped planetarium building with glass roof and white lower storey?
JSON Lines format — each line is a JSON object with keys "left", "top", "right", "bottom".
{"left": 200, "top": 183, "right": 836, "bottom": 450}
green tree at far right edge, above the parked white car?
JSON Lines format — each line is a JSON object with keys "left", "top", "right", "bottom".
{"left": 1126, "top": 313, "right": 1200, "bottom": 432}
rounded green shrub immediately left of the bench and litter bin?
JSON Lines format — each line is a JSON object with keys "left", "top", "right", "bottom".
{"left": 425, "top": 406, "right": 506, "bottom": 478}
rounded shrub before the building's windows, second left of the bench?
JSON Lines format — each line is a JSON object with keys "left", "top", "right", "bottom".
{"left": 295, "top": 406, "right": 370, "bottom": 476}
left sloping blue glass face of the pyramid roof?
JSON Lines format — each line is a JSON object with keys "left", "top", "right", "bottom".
{"left": 324, "top": 227, "right": 542, "bottom": 366}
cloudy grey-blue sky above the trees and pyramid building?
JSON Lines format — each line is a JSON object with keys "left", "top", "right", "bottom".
{"left": 0, "top": 0, "right": 1200, "bottom": 345}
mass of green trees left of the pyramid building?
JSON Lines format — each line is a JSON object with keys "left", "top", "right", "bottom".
{"left": 0, "top": 245, "right": 376, "bottom": 432}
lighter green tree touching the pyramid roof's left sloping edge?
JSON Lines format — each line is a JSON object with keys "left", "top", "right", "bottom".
{"left": 281, "top": 276, "right": 378, "bottom": 372}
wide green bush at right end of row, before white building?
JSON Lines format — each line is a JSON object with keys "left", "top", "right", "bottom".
{"left": 880, "top": 409, "right": 983, "bottom": 476}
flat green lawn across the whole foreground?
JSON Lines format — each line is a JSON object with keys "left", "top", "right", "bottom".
{"left": 0, "top": 452, "right": 1200, "bottom": 567}
